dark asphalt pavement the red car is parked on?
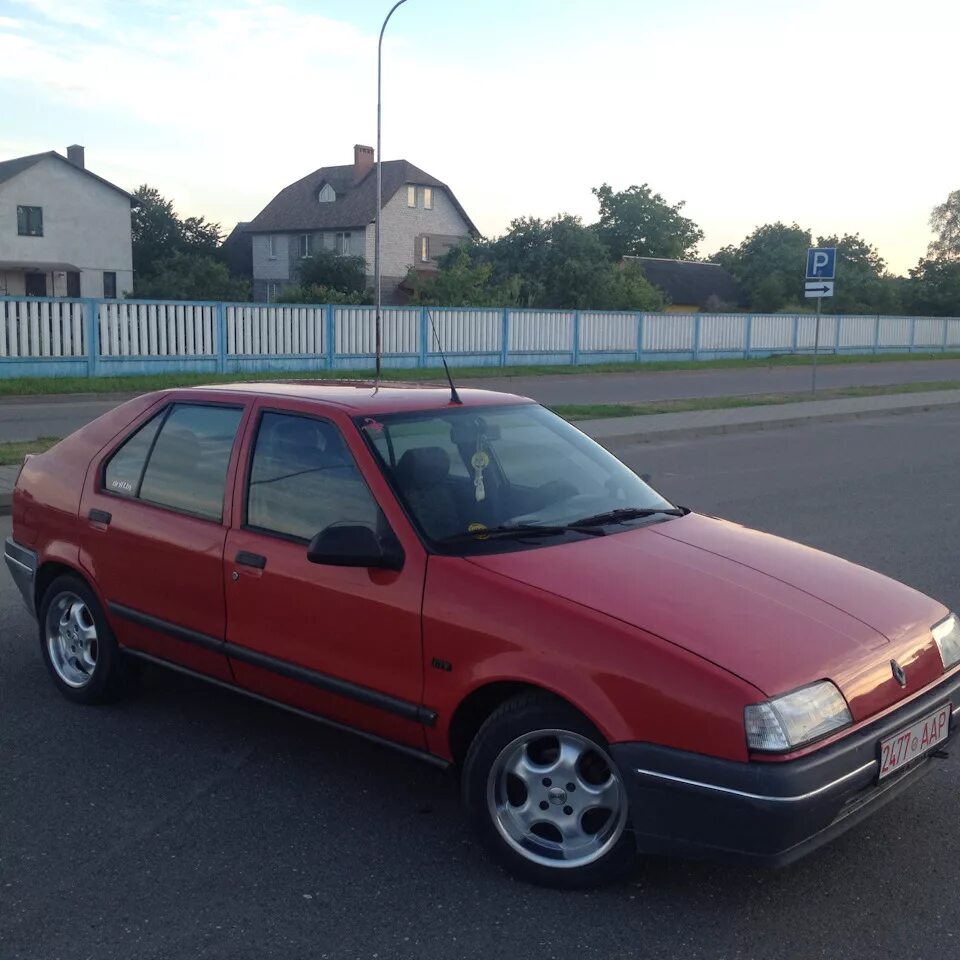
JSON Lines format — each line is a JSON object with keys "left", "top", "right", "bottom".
{"left": 0, "top": 409, "right": 960, "bottom": 960}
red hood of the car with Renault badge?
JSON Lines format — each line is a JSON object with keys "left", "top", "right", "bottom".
{"left": 470, "top": 514, "right": 947, "bottom": 719}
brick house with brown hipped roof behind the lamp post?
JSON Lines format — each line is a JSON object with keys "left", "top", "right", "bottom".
{"left": 246, "top": 144, "right": 477, "bottom": 303}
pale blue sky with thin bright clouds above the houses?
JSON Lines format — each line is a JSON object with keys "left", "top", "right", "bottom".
{"left": 0, "top": 0, "right": 960, "bottom": 273}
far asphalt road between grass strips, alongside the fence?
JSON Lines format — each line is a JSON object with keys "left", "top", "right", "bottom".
{"left": 0, "top": 360, "right": 960, "bottom": 441}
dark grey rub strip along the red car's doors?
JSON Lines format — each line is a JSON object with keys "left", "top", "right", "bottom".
{"left": 107, "top": 600, "right": 437, "bottom": 727}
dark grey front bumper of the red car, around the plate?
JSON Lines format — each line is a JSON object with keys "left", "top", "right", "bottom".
{"left": 610, "top": 674, "right": 960, "bottom": 866}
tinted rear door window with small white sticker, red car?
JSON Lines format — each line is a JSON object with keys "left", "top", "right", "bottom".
{"left": 103, "top": 403, "right": 243, "bottom": 522}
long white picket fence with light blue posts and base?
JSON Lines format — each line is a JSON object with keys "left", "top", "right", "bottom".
{"left": 0, "top": 297, "right": 960, "bottom": 376}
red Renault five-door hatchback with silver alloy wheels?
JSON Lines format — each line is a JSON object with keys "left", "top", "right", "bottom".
{"left": 6, "top": 383, "right": 960, "bottom": 886}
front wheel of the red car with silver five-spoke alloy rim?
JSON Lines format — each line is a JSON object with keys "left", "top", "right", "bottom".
{"left": 461, "top": 692, "right": 636, "bottom": 889}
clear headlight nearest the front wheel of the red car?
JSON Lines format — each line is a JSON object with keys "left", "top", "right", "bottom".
{"left": 743, "top": 680, "right": 853, "bottom": 752}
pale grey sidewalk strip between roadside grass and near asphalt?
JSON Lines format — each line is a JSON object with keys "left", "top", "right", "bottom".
{"left": 0, "top": 390, "right": 960, "bottom": 516}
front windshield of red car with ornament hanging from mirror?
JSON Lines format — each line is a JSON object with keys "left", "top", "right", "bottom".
{"left": 356, "top": 403, "right": 678, "bottom": 554}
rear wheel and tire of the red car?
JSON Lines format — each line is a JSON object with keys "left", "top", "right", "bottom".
{"left": 38, "top": 574, "right": 139, "bottom": 703}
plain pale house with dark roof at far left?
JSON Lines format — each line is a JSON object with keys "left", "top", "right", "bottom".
{"left": 0, "top": 144, "right": 136, "bottom": 298}
